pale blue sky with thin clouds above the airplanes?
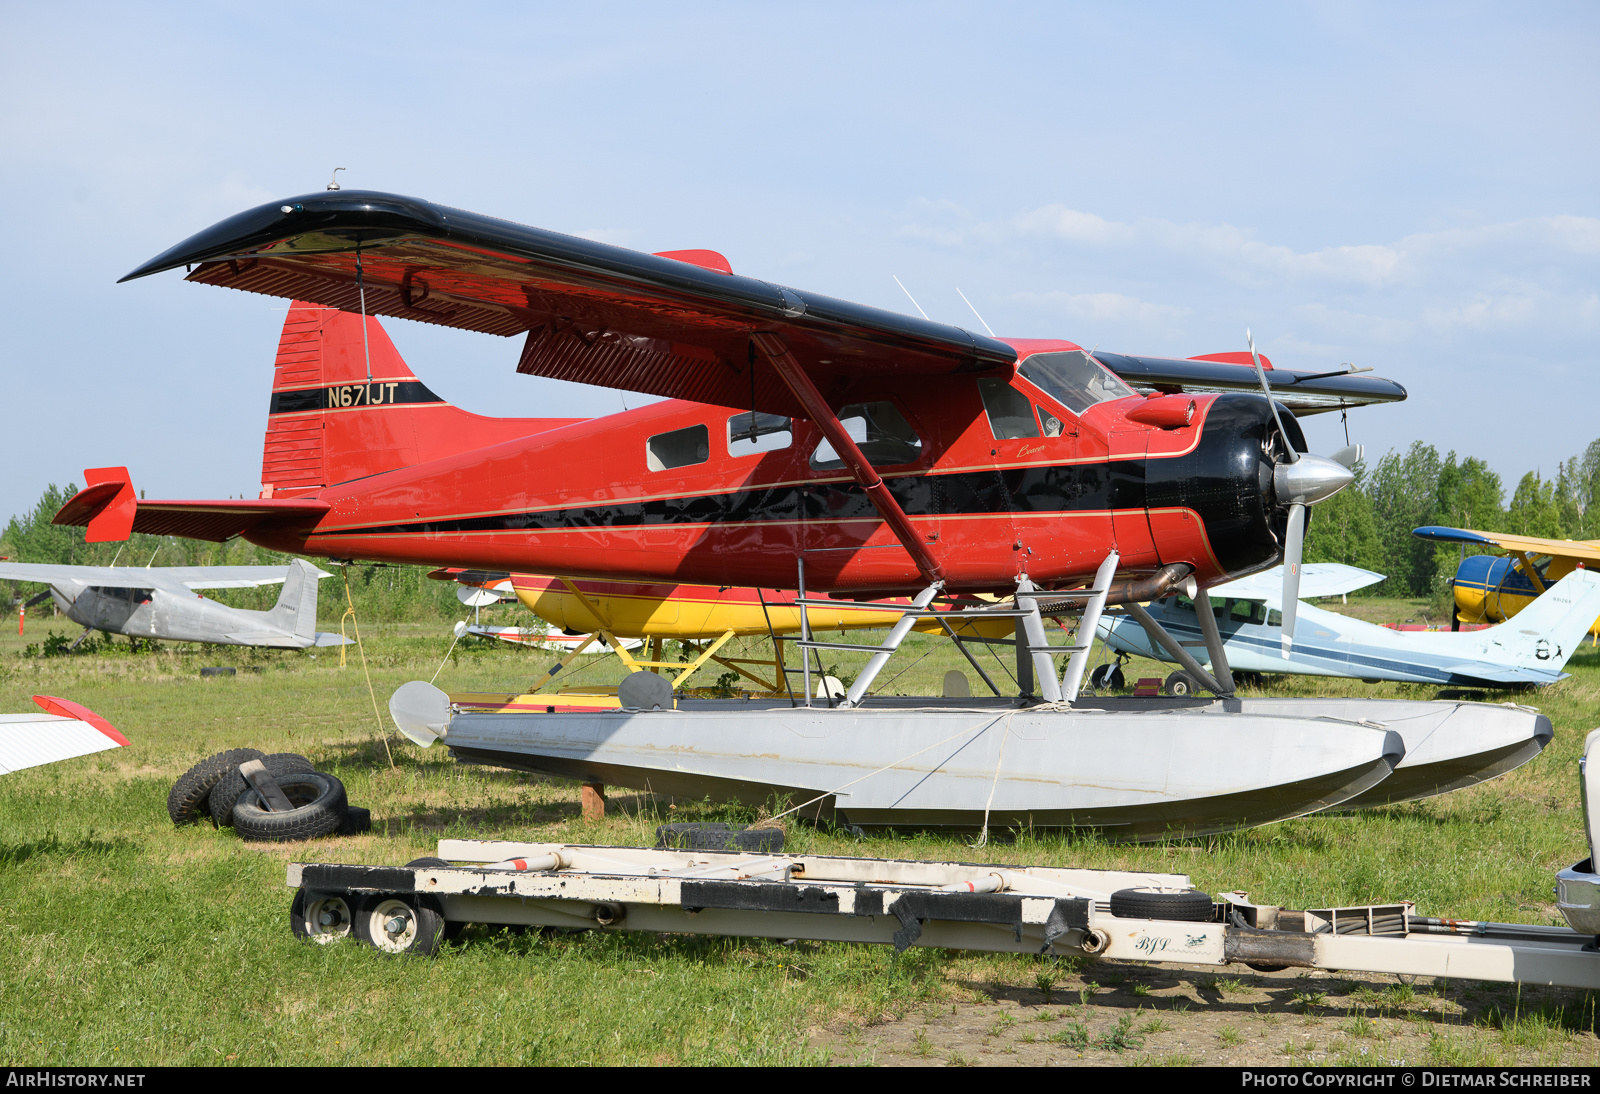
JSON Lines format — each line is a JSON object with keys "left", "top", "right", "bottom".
{"left": 0, "top": 2, "right": 1600, "bottom": 520}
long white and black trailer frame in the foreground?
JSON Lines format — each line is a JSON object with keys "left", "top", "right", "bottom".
{"left": 288, "top": 840, "right": 1600, "bottom": 988}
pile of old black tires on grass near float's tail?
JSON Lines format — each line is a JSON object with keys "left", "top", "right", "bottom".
{"left": 166, "top": 749, "right": 373, "bottom": 843}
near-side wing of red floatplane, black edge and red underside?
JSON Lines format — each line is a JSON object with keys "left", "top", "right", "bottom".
{"left": 122, "top": 190, "right": 1016, "bottom": 416}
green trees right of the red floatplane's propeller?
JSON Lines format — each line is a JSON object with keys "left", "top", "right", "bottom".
{"left": 1306, "top": 440, "right": 1600, "bottom": 597}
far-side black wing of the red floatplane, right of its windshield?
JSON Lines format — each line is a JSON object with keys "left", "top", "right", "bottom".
{"left": 1094, "top": 352, "right": 1406, "bottom": 417}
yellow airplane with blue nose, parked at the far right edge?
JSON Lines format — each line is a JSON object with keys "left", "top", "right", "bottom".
{"left": 1411, "top": 525, "right": 1600, "bottom": 645}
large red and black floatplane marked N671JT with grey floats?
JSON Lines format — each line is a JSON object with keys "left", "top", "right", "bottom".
{"left": 56, "top": 192, "right": 1549, "bottom": 840}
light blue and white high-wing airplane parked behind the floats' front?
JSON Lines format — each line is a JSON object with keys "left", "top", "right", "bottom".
{"left": 1091, "top": 563, "right": 1600, "bottom": 694}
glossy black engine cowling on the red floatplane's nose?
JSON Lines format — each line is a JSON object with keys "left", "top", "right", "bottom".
{"left": 1144, "top": 395, "right": 1309, "bottom": 576}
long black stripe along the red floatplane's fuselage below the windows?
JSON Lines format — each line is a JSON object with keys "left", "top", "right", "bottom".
{"left": 315, "top": 459, "right": 1146, "bottom": 536}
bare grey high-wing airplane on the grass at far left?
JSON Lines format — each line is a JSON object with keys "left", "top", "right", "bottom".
{"left": 0, "top": 558, "right": 347, "bottom": 649}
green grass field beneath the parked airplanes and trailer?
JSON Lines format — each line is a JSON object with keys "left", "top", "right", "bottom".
{"left": 0, "top": 600, "right": 1600, "bottom": 1065}
